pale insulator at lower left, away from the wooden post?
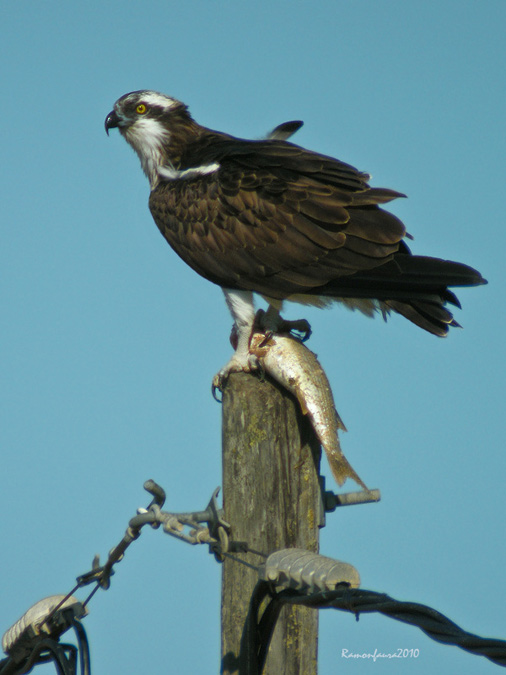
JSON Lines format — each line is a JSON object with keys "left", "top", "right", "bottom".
{"left": 2, "top": 595, "right": 87, "bottom": 654}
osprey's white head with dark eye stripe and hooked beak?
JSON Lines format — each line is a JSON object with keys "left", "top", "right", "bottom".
{"left": 105, "top": 90, "right": 194, "bottom": 186}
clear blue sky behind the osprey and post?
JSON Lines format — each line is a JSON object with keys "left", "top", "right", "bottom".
{"left": 0, "top": 0, "right": 506, "bottom": 675}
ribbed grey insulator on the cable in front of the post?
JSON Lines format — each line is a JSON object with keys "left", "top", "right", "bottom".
{"left": 259, "top": 548, "right": 360, "bottom": 593}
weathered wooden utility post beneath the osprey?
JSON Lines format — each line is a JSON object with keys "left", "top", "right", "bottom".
{"left": 222, "top": 373, "right": 321, "bottom": 675}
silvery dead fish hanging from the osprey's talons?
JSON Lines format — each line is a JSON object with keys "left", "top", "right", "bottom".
{"left": 250, "top": 333, "right": 368, "bottom": 490}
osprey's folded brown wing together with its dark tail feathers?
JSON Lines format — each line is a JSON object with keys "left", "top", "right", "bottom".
{"left": 150, "top": 133, "right": 484, "bottom": 335}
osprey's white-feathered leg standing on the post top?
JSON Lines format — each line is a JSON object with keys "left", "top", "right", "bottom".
{"left": 212, "top": 288, "right": 258, "bottom": 398}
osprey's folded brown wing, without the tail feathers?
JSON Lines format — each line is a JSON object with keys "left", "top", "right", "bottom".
{"left": 149, "top": 139, "right": 405, "bottom": 298}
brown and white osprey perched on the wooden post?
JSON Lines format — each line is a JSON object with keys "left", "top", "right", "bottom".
{"left": 105, "top": 90, "right": 486, "bottom": 384}
